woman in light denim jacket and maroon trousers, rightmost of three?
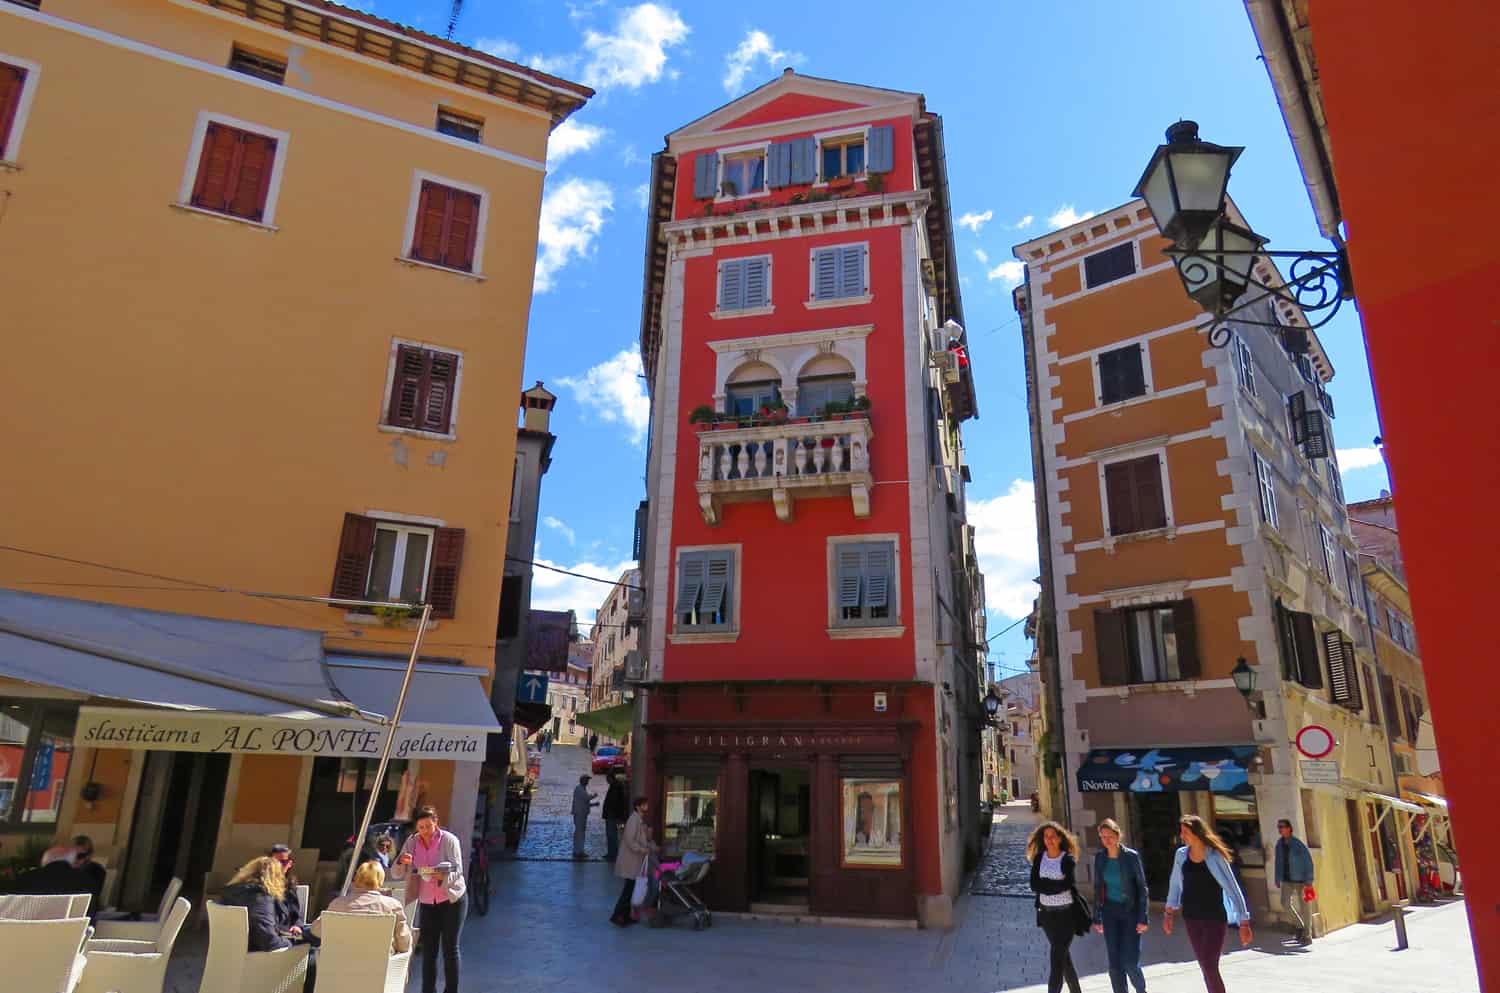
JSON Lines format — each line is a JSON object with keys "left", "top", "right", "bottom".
{"left": 1161, "top": 813, "right": 1254, "bottom": 993}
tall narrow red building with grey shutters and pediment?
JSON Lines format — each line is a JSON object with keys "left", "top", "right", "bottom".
{"left": 638, "top": 71, "right": 984, "bottom": 924}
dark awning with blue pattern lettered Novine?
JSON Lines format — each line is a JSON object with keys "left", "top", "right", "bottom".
{"left": 1079, "top": 746, "right": 1257, "bottom": 795}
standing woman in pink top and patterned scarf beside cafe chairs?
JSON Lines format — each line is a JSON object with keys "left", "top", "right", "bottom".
{"left": 390, "top": 804, "right": 468, "bottom": 993}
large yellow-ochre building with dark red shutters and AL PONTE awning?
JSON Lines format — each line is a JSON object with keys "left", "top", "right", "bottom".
{"left": 0, "top": 0, "right": 591, "bottom": 906}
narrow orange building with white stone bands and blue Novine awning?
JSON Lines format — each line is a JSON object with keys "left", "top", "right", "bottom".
{"left": 1016, "top": 201, "right": 1422, "bottom": 930}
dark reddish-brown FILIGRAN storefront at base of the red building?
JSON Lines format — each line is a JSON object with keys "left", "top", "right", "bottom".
{"left": 647, "top": 720, "right": 917, "bottom": 918}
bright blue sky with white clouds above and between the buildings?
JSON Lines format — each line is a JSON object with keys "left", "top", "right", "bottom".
{"left": 360, "top": 0, "right": 1388, "bottom": 677}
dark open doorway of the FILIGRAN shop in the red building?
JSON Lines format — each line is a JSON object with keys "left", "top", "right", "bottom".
{"left": 749, "top": 767, "right": 813, "bottom": 908}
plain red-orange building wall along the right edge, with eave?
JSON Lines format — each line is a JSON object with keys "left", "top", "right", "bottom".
{"left": 1242, "top": 0, "right": 1500, "bottom": 990}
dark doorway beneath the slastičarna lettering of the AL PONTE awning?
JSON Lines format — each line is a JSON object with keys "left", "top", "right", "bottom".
{"left": 117, "top": 752, "right": 230, "bottom": 911}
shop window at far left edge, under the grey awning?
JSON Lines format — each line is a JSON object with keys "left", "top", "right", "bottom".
{"left": 0, "top": 701, "right": 78, "bottom": 830}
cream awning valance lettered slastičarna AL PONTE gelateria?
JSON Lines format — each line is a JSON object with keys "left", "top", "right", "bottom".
{"left": 75, "top": 707, "right": 488, "bottom": 762}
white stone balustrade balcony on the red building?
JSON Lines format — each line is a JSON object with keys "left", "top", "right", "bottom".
{"left": 698, "top": 417, "right": 875, "bottom": 525}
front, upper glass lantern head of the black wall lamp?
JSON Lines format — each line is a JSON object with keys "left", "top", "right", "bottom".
{"left": 1131, "top": 120, "right": 1245, "bottom": 248}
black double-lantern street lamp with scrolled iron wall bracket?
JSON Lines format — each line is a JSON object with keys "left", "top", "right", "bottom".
{"left": 1134, "top": 120, "right": 1353, "bottom": 348}
